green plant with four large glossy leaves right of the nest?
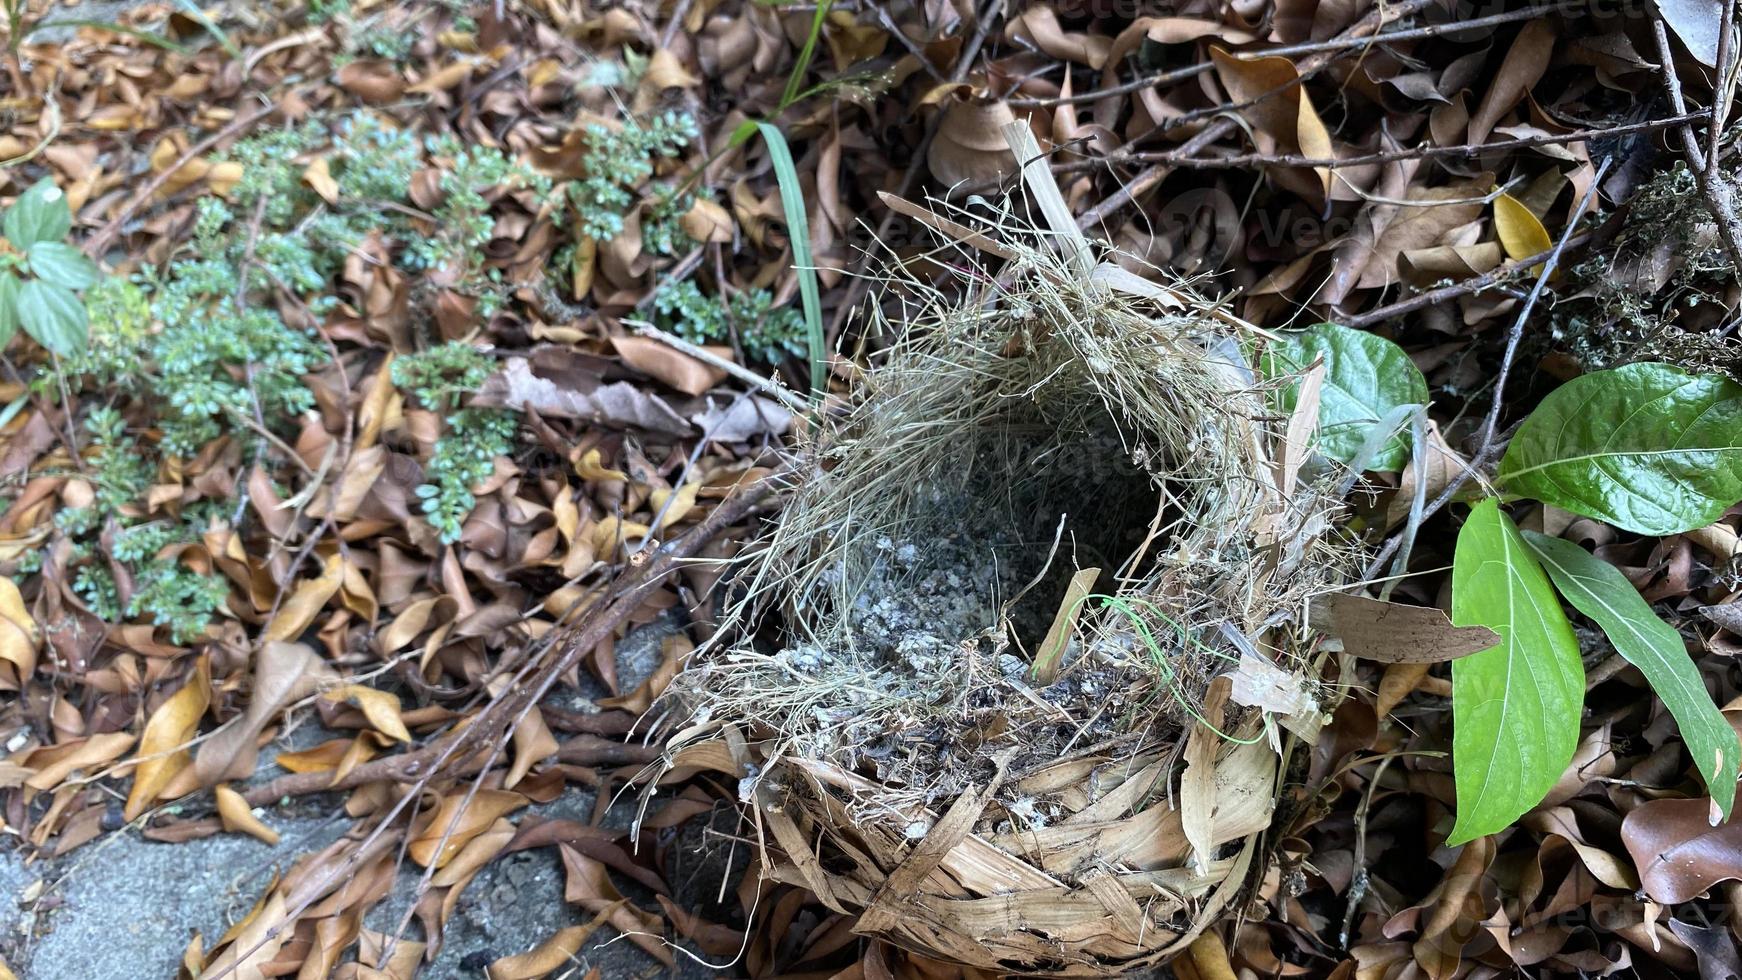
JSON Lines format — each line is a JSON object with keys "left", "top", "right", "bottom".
{"left": 1261, "top": 326, "right": 1742, "bottom": 844}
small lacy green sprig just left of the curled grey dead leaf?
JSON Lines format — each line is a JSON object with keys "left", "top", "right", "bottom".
{"left": 392, "top": 341, "right": 519, "bottom": 543}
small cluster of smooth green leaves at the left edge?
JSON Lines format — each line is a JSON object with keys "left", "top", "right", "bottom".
{"left": 0, "top": 178, "right": 98, "bottom": 357}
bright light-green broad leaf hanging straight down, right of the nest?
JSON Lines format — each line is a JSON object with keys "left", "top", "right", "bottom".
{"left": 1446, "top": 498, "right": 1585, "bottom": 844}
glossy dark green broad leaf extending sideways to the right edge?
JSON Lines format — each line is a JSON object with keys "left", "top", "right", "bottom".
{"left": 1496, "top": 364, "right": 1742, "bottom": 534}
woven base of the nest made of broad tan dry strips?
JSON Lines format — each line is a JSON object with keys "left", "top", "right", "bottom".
{"left": 665, "top": 728, "right": 1279, "bottom": 977}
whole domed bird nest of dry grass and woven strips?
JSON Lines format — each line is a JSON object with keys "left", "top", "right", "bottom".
{"left": 664, "top": 124, "right": 1348, "bottom": 977}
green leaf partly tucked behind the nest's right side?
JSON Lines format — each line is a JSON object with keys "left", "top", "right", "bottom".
{"left": 1259, "top": 324, "right": 1427, "bottom": 470}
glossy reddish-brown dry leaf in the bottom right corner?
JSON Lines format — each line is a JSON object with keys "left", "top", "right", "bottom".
{"left": 1622, "top": 799, "right": 1742, "bottom": 905}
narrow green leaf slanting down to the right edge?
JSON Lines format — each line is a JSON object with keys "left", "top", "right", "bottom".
{"left": 1524, "top": 531, "right": 1742, "bottom": 820}
